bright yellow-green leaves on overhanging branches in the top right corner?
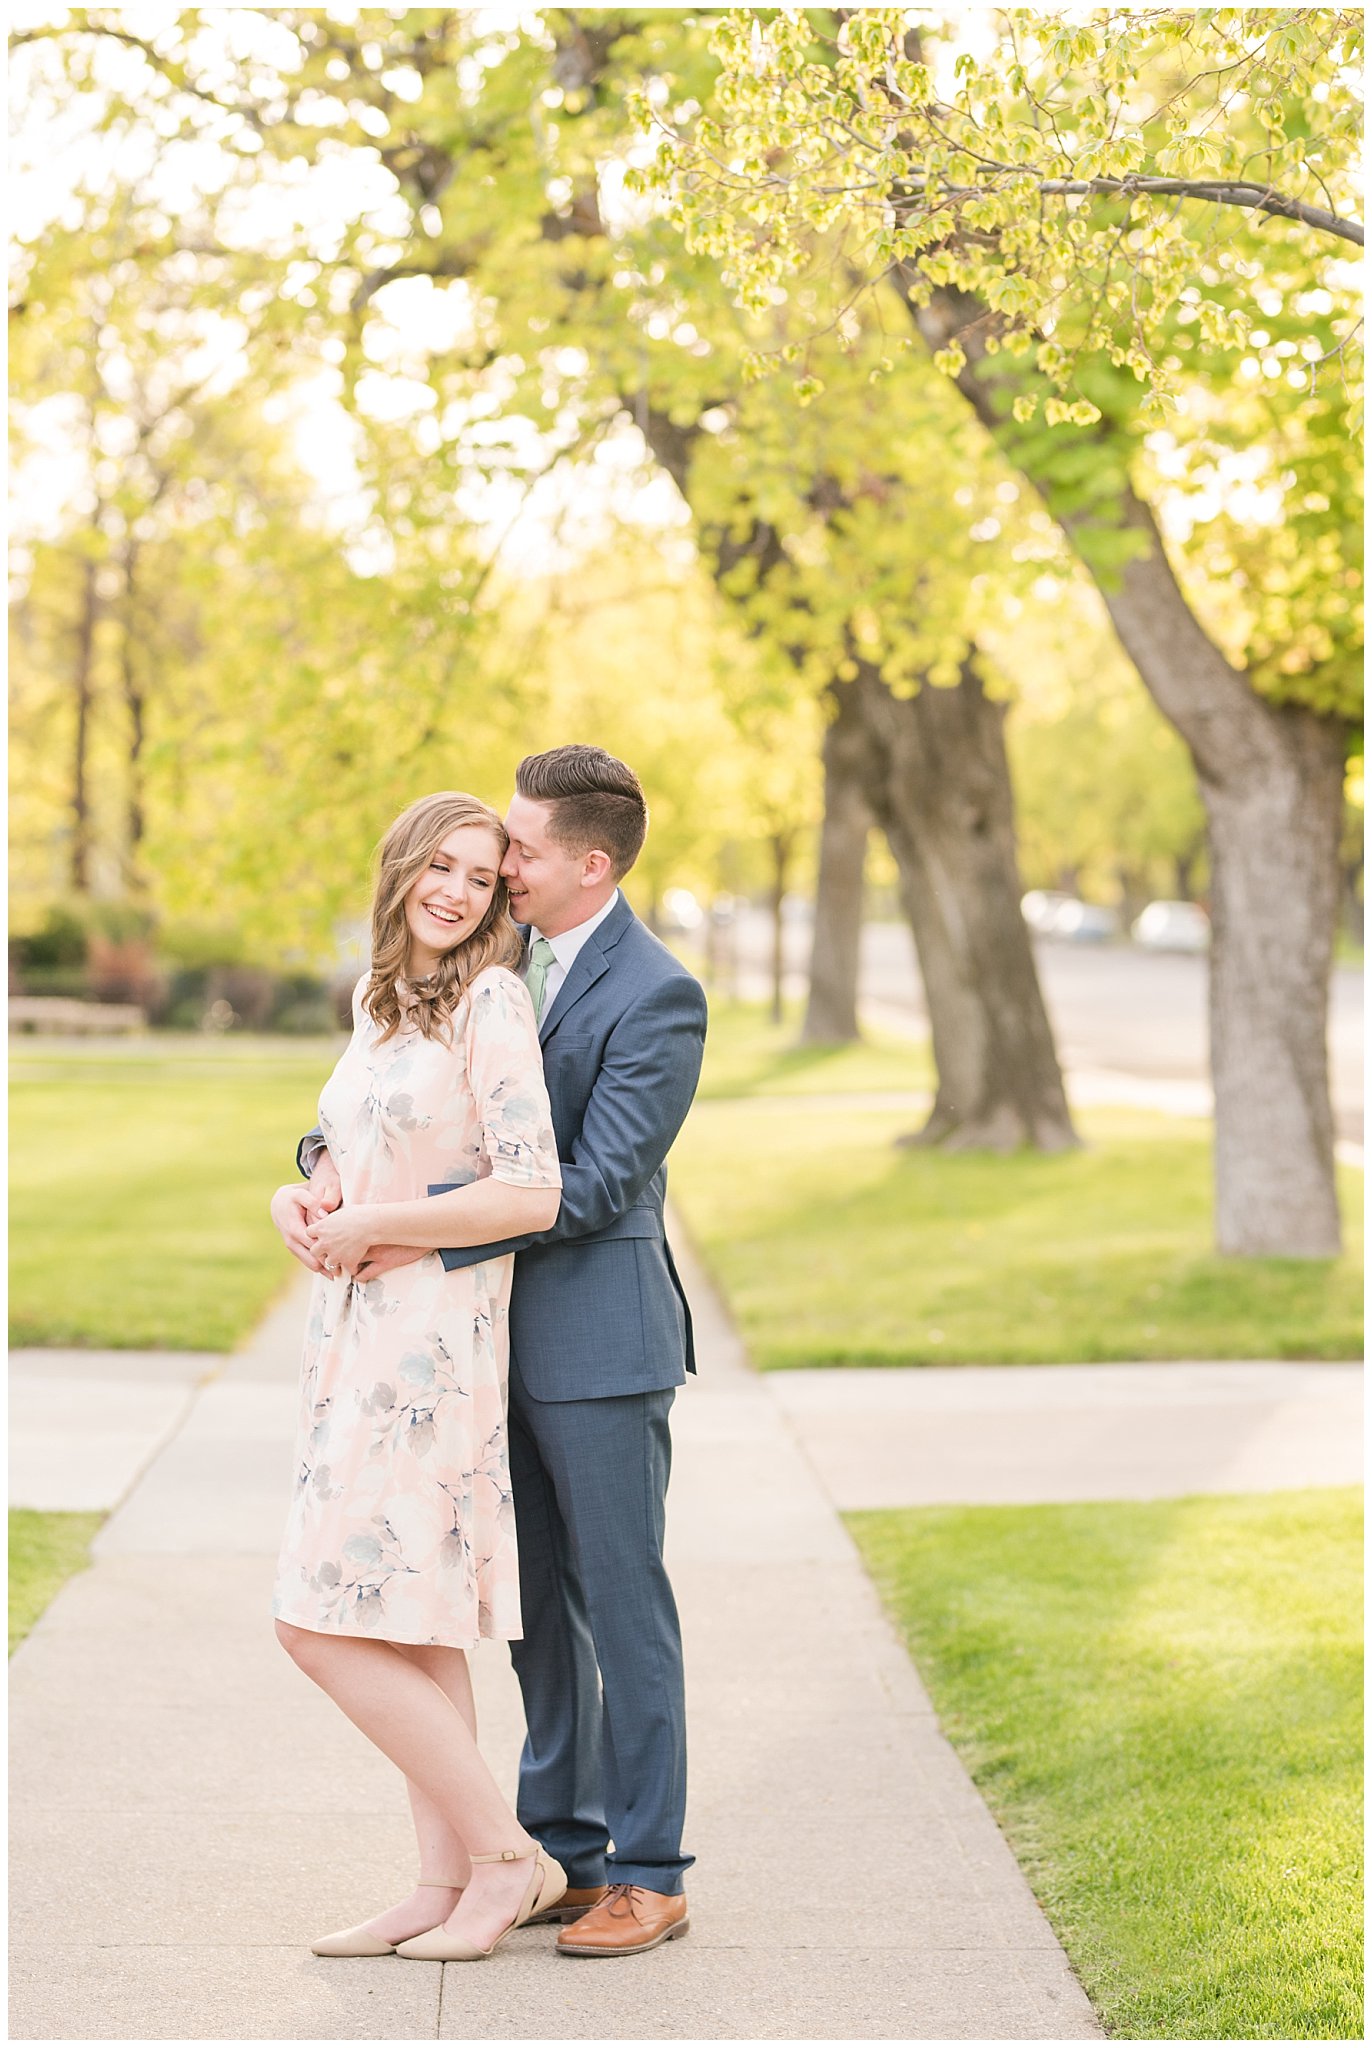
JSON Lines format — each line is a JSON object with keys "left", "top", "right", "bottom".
{"left": 655, "top": 8, "right": 1360, "bottom": 420}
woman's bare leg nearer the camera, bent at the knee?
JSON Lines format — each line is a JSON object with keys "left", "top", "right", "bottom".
{"left": 276, "top": 1622, "right": 537, "bottom": 1948}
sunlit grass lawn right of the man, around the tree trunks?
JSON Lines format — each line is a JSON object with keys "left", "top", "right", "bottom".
{"left": 672, "top": 1006, "right": 1362, "bottom": 1368}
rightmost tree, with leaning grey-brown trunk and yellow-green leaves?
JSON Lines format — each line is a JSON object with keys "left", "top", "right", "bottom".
{"left": 651, "top": 8, "right": 1358, "bottom": 1255}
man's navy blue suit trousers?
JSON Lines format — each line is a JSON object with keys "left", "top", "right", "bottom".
{"left": 510, "top": 1360, "right": 694, "bottom": 1892}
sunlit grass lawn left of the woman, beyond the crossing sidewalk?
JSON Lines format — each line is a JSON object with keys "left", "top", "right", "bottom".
{"left": 10, "top": 1036, "right": 338, "bottom": 1352}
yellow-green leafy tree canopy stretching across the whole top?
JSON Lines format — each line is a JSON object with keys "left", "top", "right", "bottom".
{"left": 14, "top": 8, "right": 1358, "bottom": 946}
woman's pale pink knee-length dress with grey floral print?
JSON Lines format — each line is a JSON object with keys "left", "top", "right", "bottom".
{"left": 272, "top": 967, "right": 561, "bottom": 1649}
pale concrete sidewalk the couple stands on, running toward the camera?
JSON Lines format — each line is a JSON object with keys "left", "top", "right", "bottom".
{"left": 10, "top": 1266, "right": 1100, "bottom": 2040}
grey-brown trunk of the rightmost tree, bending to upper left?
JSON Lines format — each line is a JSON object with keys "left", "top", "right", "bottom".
{"left": 907, "top": 276, "right": 1343, "bottom": 1257}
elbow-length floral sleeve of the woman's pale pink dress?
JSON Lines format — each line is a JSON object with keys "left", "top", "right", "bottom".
{"left": 465, "top": 969, "right": 563, "bottom": 1188}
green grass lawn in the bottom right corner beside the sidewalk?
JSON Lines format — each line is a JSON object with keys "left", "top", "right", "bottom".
{"left": 848, "top": 1489, "right": 1362, "bottom": 2040}
